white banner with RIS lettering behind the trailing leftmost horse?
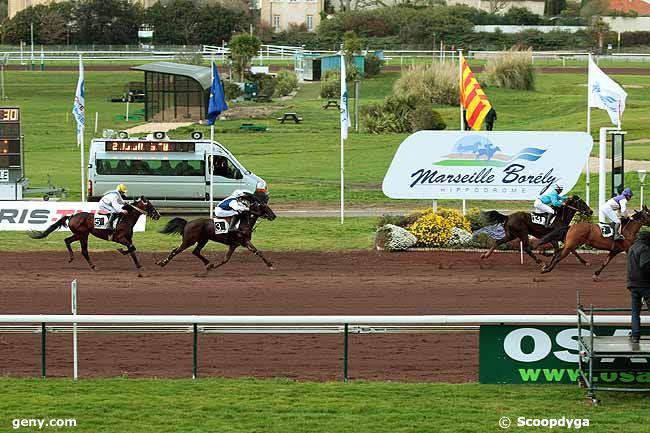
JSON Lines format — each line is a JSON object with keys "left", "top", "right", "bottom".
{"left": 0, "top": 201, "right": 147, "bottom": 232}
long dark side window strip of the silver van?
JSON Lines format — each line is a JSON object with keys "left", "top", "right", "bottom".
{"left": 97, "top": 159, "right": 205, "bottom": 176}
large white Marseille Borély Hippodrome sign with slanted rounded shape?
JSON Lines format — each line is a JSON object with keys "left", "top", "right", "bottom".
{"left": 382, "top": 131, "right": 593, "bottom": 200}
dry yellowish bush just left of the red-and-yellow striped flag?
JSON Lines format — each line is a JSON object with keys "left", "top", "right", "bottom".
{"left": 393, "top": 63, "right": 458, "bottom": 105}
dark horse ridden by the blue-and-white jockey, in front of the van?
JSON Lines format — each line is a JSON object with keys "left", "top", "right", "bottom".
{"left": 157, "top": 196, "right": 276, "bottom": 273}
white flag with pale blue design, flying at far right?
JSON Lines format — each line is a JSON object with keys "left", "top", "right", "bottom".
{"left": 588, "top": 57, "right": 627, "bottom": 125}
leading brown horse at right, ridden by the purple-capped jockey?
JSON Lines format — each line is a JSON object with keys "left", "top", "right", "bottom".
{"left": 540, "top": 205, "right": 650, "bottom": 281}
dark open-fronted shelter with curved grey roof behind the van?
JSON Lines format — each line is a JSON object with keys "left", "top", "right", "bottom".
{"left": 131, "top": 62, "right": 212, "bottom": 122}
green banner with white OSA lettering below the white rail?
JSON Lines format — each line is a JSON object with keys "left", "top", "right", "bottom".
{"left": 479, "top": 325, "right": 650, "bottom": 384}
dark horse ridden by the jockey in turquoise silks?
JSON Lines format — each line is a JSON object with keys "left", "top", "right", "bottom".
{"left": 481, "top": 195, "right": 594, "bottom": 266}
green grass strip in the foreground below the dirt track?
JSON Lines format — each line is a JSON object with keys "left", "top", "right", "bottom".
{"left": 0, "top": 379, "right": 647, "bottom": 433}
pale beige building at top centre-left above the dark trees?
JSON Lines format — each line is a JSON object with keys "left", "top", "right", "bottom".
{"left": 258, "top": 0, "right": 324, "bottom": 32}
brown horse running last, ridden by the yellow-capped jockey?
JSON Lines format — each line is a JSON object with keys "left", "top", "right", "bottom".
{"left": 27, "top": 197, "right": 160, "bottom": 277}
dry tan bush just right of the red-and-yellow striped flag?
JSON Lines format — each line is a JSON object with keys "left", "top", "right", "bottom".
{"left": 484, "top": 48, "right": 535, "bottom": 90}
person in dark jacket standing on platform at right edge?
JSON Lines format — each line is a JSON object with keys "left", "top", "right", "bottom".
{"left": 627, "top": 231, "right": 650, "bottom": 343}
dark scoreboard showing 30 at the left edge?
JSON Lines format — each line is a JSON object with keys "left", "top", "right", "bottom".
{"left": 0, "top": 107, "right": 24, "bottom": 200}
